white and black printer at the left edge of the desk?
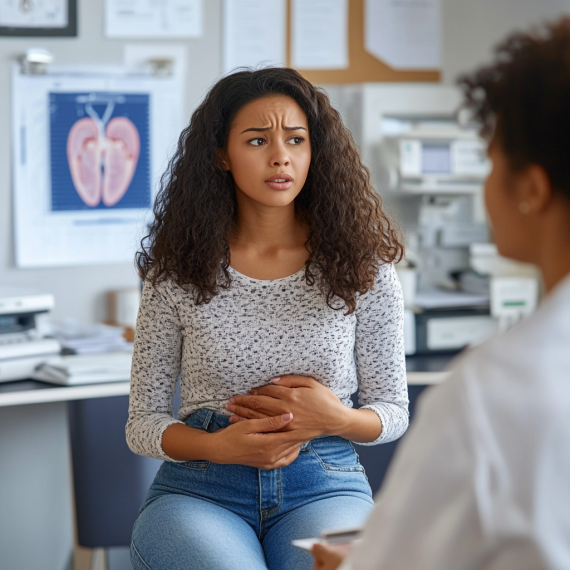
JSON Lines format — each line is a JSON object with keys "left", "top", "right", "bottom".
{"left": 0, "top": 288, "right": 61, "bottom": 382}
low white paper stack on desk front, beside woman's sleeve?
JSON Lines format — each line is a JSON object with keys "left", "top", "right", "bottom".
{"left": 32, "top": 352, "right": 133, "bottom": 386}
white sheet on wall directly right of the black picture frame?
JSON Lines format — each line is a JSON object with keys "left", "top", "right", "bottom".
{"left": 105, "top": 0, "right": 204, "bottom": 38}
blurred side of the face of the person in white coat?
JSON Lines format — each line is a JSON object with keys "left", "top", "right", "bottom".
{"left": 485, "top": 140, "right": 533, "bottom": 262}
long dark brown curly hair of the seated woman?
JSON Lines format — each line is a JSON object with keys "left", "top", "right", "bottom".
{"left": 136, "top": 68, "right": 403, "bottom": 314}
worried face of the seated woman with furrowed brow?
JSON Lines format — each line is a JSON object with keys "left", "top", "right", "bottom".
{"left": 222, "top": 96, "right": 311, "bottom": 206}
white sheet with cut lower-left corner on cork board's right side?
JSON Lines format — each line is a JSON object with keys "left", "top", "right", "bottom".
{"left": 364, "top": 0, "right": 441, "bottom": 70}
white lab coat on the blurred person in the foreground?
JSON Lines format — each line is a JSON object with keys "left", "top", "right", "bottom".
{"left": 341, "top": 276, "right": 570, "bottom": 570}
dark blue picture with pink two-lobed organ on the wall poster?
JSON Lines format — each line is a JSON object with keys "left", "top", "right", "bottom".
{"left": 49, "top": 92, "right": 151, "bottom": 212}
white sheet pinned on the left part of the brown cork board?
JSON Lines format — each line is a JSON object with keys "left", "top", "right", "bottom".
{"left": 291, "top": 0, "right": 348, "bottom": 69}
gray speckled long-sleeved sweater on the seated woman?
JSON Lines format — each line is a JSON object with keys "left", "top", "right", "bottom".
{"left": 126, "top": 264, "right": 408, "bottom": 461}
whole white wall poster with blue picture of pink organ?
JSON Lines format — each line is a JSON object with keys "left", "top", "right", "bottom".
{"left": 12, "top": 65, "right": 185, "bottom": 267}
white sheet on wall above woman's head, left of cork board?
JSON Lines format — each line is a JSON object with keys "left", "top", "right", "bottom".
{"left": 222, "top": 0, "right": 287, "bottom": 73}
